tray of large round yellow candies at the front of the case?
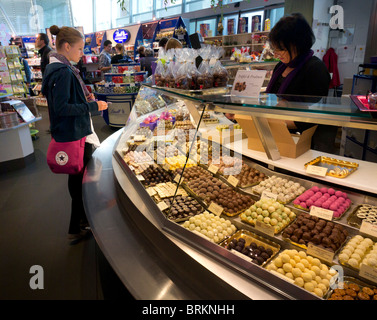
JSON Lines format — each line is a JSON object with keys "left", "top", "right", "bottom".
{"left": 266, "top": 249, "right": 337, "bottom": 298}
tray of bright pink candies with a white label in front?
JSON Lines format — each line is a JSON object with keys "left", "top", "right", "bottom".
{"left": 293, "top": 186, "right": 352, "bottom": 220}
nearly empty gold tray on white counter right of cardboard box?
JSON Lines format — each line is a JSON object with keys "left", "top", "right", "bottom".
{"left": 305, "top": 157, "right": 359, "bottom": 178}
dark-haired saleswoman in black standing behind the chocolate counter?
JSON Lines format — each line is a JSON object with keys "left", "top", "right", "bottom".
{"left": 266, "top": 13, "right": 338, "bottom": 153}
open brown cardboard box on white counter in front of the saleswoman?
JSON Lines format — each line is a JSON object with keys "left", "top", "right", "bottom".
{"left": 235, "top": 115, "right": 317, "bottom": 158}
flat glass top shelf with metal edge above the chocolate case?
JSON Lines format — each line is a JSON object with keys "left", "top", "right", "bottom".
{"left": 146, "top": 85, "right": 377, "bottom": 130}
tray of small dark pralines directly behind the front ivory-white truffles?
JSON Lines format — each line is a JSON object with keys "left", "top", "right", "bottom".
{"left": 163, "top": 196, "right": 204, "bottom": 222}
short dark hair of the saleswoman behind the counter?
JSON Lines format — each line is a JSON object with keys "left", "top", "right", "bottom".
{"left": 269, "top": 13, "right": 315, "bottom": 57}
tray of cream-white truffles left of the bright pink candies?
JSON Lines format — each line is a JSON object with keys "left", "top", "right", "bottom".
{"left": 252, "top": 175, "right": 306, "bottom": 204}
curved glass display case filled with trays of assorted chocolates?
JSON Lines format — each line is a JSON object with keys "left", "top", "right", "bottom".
{"left": 109, "top": 85, "right": 377, "bottom": 299}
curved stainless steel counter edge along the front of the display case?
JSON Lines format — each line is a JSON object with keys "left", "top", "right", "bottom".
{"left": 83, "top": 129, "right": 283, "bottom": 300}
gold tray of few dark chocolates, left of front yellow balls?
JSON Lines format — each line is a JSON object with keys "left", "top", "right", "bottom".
{"left": 220, "top": 229, "right": 280, "bottom": 267}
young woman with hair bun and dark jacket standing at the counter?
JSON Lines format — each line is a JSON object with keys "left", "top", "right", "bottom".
{"left": 42, "top": 26, "right": 107, "bottom": 244}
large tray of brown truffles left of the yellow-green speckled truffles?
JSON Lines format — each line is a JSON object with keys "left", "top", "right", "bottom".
{"left": 186, "top": 177, "right": 254, "bottom": 217}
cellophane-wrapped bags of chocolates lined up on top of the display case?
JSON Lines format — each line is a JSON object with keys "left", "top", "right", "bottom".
{"left": 154, "top": 46, "right": 229, "bottom": 90}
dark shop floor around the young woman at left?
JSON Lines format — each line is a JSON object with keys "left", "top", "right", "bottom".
{"left": 0, "top": 107, "right": 131, "bottom": 300}
